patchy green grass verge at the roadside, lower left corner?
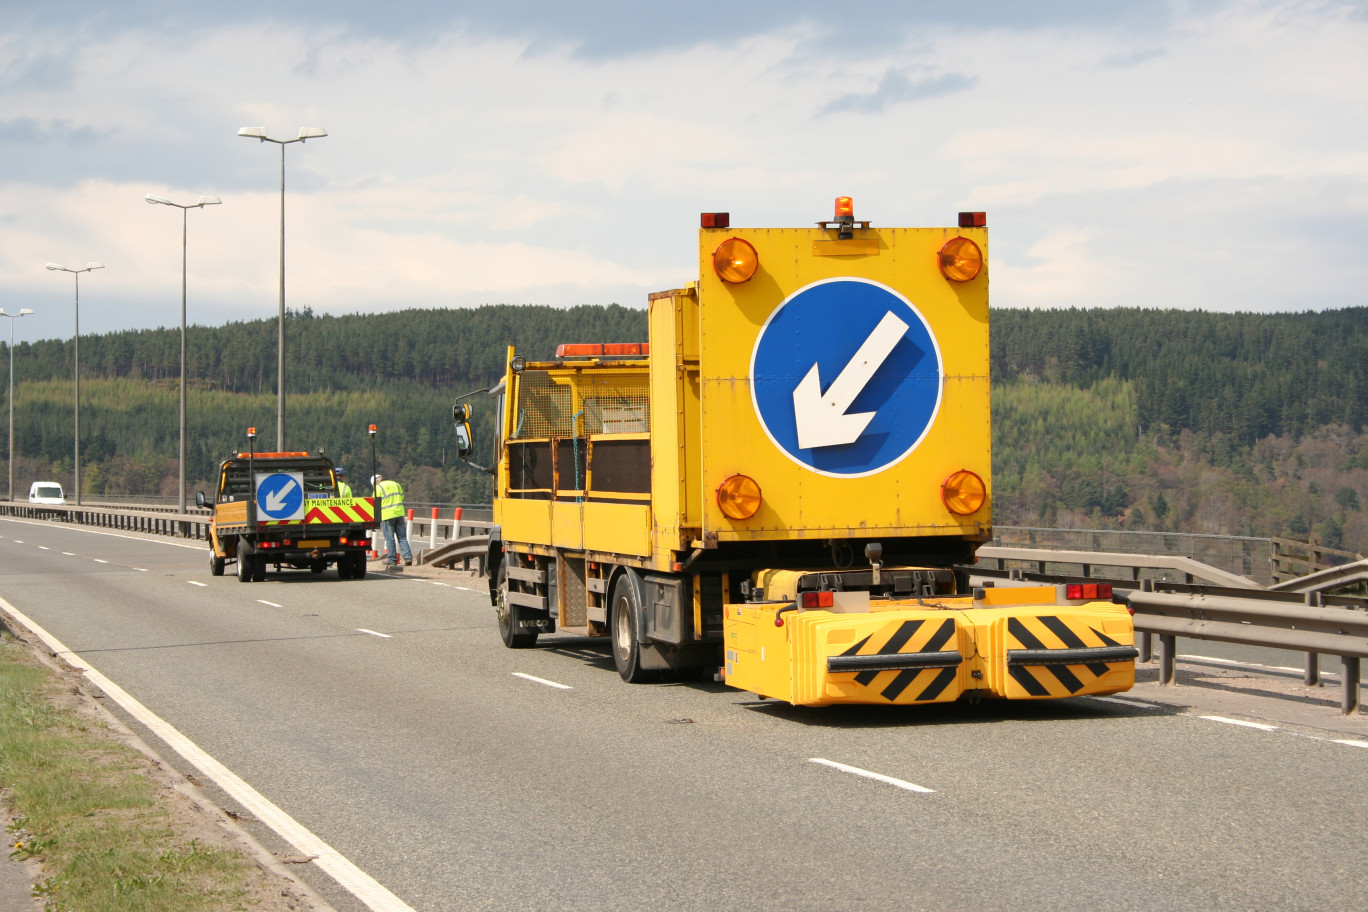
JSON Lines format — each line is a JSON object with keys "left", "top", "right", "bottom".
{"left": 0, "top": 629, "right": 260, "bottom": 912}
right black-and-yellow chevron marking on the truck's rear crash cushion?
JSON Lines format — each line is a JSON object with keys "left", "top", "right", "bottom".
{"left": 1007, "top": 615, "right": 1140, "bottom": 697}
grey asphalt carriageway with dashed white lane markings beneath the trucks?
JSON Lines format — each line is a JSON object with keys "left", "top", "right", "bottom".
{"left": 0, "top": 520, "right": 1368, "bottom": 912}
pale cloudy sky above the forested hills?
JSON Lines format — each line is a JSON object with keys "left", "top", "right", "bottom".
{"left": 0, "top": 0, "right": 1368, "bottom": 342}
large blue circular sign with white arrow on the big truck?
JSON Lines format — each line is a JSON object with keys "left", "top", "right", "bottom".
{"left": 751, "top": 278, "right": 944, "bottom": 477}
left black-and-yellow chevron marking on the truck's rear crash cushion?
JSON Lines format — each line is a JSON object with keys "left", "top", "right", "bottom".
{"left": 826, "top": 618, "right": 963, "bottom": 701}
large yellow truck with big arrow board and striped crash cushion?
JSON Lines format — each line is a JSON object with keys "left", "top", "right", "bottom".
{"left": 456, "top": 197, "right": 1137, "bottom": 706}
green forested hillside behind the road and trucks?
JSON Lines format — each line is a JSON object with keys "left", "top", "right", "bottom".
{"left": 0, "top": 305, "right": 1368, "bottom": 551}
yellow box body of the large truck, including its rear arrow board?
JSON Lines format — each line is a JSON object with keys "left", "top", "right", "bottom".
{"left": 495, "top": 222, "right": 992, "bottom": 570}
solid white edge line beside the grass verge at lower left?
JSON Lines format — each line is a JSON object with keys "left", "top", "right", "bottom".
{"left": 0, "top": 598, "right": 417, "bottom": 912}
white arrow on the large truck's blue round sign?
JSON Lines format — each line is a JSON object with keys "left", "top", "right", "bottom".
{"left": 793, "top": 312, "right": 907, "bottom": 450}
